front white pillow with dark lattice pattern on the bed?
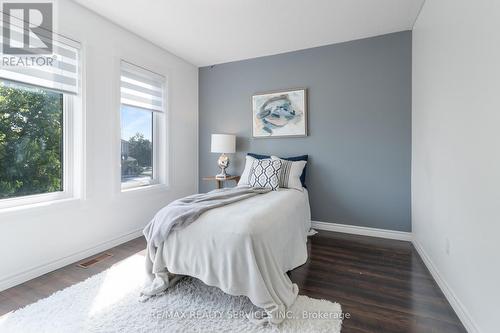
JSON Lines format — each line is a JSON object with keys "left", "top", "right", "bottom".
{"left": 248, "top": 159, "right": 281, "bottom": 191}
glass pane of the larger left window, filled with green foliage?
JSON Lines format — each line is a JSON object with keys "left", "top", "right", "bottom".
{"left": 0, "top": 80, "right": 64, "bottom": 199}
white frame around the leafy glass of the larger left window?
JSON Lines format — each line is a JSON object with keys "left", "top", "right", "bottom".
{"left": 0, "top": 88, "right": 79, "bottom": 211}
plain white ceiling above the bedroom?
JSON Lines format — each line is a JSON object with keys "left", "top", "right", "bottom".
{"left": 74, "top": 0, "right": 424, "bottom": 66}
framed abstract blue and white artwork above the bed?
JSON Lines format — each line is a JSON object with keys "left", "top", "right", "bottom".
{"left": 252, "top": 89, "right": 307, "bottom": 138}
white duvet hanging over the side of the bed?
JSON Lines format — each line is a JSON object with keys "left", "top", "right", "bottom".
{"left": 143, "top": 189, "right": 311, "bottom": 323}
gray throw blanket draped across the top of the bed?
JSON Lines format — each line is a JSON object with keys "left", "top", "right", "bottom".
{"left": 143, "top": 187, "right": 271, "bottom": 248}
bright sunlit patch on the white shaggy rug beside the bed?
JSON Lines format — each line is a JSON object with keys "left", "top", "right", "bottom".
{"left": 88, "top": 254, "right": 146, "bottom": 317}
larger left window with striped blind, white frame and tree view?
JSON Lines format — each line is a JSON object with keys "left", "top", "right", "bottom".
{"left": 0, "top": 30, "right": 79, "bottom": 208}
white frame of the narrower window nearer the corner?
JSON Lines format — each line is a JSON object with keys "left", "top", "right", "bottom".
{"left": 118, "top": 59, "right": 168, "bottom": 193}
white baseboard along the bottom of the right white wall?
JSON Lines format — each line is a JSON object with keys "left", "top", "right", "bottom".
{"left": 412, "top": 238, "right": 480, "bottom": 333}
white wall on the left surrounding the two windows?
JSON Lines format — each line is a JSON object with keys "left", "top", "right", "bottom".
{"left": 0, "top": 1, "right": 198, "bottom": 290}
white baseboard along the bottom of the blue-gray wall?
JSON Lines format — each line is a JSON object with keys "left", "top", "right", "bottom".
{"left": 311, "top": 221, "right": 412, "bottom": 242}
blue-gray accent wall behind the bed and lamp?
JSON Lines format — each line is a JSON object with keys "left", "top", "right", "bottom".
{"left": 199, "top": 31, "right": 411, "bottom": 231}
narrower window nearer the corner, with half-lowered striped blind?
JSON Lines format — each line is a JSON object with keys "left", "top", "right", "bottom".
{"left": 120, "top": 61, "right": 165, "bottom": 189}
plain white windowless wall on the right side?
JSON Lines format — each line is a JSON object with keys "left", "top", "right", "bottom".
{"left": 412, "top": 0, "right": 500, "bottom": 332}
